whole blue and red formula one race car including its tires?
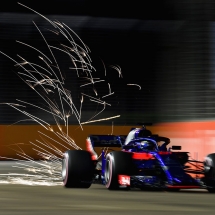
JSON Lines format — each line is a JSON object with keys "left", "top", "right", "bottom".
{"left": 62, "top": 125, "right": 215, "bottom": 192}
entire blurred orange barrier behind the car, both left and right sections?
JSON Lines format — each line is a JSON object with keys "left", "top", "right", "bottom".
{"left": 0, "top": 121, "right": 215, "bottom": 161}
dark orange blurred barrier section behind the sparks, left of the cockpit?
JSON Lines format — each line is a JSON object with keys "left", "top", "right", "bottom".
{"left": 0, "top": 125, "right": 131, "bottom": 160}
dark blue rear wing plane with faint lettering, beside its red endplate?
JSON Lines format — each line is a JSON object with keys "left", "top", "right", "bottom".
{"left": 88, "top": 135, "right": 126, "bottom": 148}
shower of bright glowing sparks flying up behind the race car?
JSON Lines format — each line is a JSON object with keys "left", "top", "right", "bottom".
{"left": 0, "top": 3, "right": 141, "bottom": 186}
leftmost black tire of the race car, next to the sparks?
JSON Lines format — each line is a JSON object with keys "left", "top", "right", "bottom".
{"left": 62, "top": 150, "right": 94, "bottom": 188}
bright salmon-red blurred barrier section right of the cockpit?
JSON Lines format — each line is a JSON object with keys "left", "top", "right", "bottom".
{"left": 154, "top": 121, "right": 215, "bottom": 161}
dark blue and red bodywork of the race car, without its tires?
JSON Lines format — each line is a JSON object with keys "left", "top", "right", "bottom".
{"left": 87, "top": 127, "right": 215, "bottom": 191}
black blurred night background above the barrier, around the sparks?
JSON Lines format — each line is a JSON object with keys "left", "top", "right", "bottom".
{"left": 0, "top": 0, "right": 215, "bottom": 125}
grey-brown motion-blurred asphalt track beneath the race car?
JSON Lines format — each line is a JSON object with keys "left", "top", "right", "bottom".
{"left": 0, "top": 161, "right": 215, "bottom": 215}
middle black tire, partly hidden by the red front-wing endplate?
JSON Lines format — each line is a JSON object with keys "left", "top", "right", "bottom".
{"left": 104, "top": 151, "right": 133, "bottom": 190}
